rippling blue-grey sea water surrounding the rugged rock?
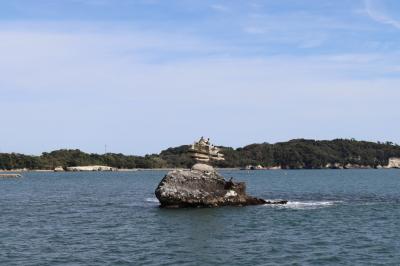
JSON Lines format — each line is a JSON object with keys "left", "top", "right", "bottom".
{"left": 0, "top": 170, "right": 400, "bottom": 265}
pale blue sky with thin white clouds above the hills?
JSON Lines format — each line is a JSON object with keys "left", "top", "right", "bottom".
{"left": 0, "top": 0, "right": 400, "bottom": 155}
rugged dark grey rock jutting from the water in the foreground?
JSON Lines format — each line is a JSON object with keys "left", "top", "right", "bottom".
{"left": 155, "top": 164, "right": 287, "bottom": 208}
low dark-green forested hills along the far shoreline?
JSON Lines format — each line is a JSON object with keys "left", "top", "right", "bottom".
{"left": 0, "top": 139, "right": 400, "bottom": 170}
